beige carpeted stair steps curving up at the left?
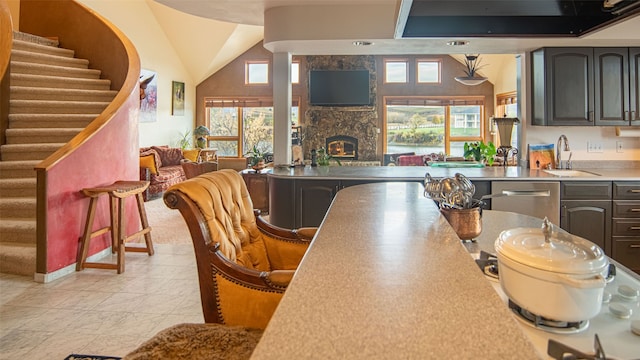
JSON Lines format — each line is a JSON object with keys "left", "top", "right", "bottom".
{"left": 0, "top": 32, "right": 117, "bottom": 276}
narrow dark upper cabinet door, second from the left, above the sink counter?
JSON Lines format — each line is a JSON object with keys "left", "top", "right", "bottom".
{"left": 593, "top": 48, "right": 630, "bottom": 125}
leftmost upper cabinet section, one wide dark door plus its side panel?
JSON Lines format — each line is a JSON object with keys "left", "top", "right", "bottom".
{"left": 531, "top": 47, "right": 594, "bottom": 126}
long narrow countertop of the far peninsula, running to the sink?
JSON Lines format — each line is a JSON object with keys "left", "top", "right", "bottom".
{"left": 265, "top": 166, "right": 640, "bottom": 181}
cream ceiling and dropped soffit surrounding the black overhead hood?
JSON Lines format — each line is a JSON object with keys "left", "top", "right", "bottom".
{"left": 147, "top": 0, "right": 640, "bottom": 81}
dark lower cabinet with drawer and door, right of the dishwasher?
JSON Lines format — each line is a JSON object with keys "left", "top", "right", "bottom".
{"left": 560, "top": 181, "right": 612, "bottom": 255}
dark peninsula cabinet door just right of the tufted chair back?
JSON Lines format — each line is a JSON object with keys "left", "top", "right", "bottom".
{"left": 296, "top": 180, "right": 340, "bottom": 227}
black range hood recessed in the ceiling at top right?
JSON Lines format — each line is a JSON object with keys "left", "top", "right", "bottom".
{"left": 396, "top": 0, "right": 640, "bottom": 38}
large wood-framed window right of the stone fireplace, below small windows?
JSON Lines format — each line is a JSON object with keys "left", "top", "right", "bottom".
{"left": 384, "top": 97, "right": 484, "bottom": 156}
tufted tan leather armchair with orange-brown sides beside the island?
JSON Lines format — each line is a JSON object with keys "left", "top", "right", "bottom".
{"left": 164, "top": 169, "right": 316, "bottom": 329}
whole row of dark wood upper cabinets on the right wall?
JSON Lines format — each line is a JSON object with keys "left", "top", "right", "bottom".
{"left": 532, "top": 48, "right": 640, "bottom": 126}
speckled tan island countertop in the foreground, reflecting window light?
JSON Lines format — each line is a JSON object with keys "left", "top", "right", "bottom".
{"left": 252, "top": 182, "right": 543, "bottom": 359}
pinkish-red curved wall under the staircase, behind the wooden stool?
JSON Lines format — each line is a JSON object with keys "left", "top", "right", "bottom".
{"left": 46, "top": 87, "right": 140, "bottom": 273}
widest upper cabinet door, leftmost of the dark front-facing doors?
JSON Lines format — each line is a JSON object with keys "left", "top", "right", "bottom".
{"left": 545, "top": 48, "right": 594, "bottom": 126}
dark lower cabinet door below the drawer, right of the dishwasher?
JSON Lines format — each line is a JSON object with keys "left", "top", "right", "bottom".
{"left": 560, "top": 200, "right": 611, "bottom": 255}
